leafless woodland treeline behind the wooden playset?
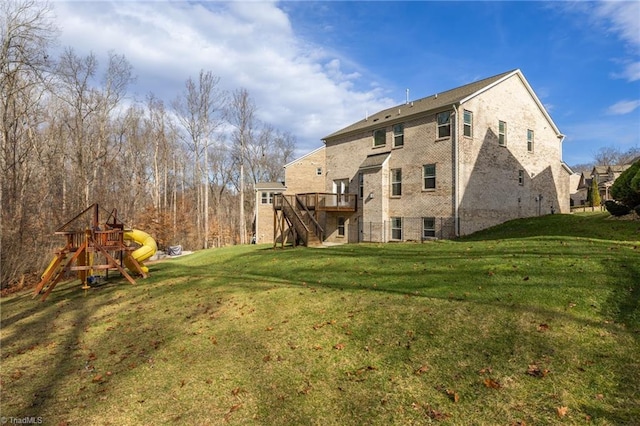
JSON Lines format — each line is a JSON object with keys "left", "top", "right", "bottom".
{"left": 0, "top": 0, "right": 295, "bottom": 288}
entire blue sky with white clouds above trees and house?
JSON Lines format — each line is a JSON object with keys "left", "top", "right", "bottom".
{"left": 53, "top": 1, "right": 640, "bottom": 165}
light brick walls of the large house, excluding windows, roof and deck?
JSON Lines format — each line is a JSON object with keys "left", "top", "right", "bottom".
{"left": 266, "top": 72, "right": 570, "bottom": 242}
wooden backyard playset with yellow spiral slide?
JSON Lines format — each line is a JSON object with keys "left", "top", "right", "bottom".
{"left": 33, "top": 204, "right": 157, "bottom": 301}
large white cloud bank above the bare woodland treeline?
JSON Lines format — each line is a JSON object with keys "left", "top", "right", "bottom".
{"left": 54, "top": 1, "right": 394, "bottom": 152}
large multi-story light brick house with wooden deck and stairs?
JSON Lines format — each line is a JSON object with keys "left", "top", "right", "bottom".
{"left": 262, "top": 70, "right": 572, "bottom": 244}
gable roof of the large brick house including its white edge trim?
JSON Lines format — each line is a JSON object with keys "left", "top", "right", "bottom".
{"left": 323, "top": 69, "right": 563, "bottom": 141}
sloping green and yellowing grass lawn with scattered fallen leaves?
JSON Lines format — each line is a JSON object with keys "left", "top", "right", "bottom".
{"left": 0, "top": 214, "right": 640, "bottom": 425}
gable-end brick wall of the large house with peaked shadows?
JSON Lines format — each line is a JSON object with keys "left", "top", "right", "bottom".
{"left": 456, "top": 75, "right": 570, "bottom": 235}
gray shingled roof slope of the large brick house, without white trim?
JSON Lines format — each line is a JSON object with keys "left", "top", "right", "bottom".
{"left": 323, "top": 70, "right": 518, "bottom": 140}
